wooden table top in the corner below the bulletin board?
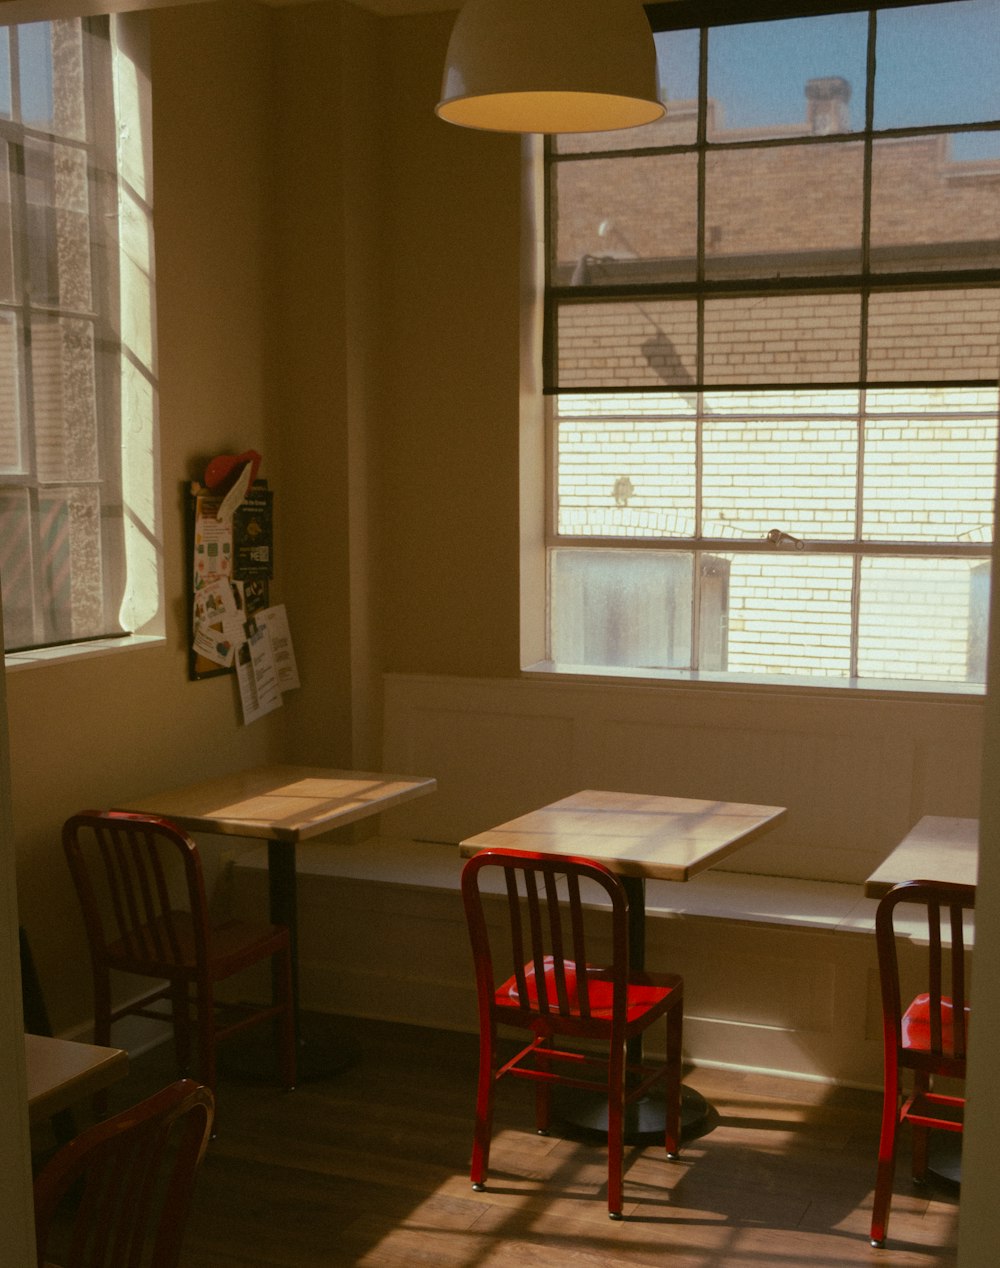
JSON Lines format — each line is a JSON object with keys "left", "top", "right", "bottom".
{"left": 115, "top": 765, "right": 437, "bottom": 844}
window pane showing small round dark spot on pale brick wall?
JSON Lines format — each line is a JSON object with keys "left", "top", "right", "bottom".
{"left": 556, "top": 402, "right": 696, "bottom": 538}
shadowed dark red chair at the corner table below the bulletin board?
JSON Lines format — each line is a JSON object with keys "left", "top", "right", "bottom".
{"left": 62, "top": 810, "right": 295, "bottom": 1090}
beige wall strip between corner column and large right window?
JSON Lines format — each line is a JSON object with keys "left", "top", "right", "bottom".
{"left": 379, "top": 7, "right": 521, "bottom": 676}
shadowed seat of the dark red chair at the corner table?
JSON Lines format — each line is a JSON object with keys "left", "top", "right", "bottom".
{"left": 108, "top": 912, "right": 288, "bottom": 978}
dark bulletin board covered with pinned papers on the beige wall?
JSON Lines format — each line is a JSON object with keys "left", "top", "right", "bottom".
{"left": 188, "top": 479, "right": 274, "bottom": 678}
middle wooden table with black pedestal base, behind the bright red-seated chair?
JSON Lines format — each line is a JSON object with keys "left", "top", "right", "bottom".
{"left": 459, "top": 790, "right": 786, "bottom": 1141}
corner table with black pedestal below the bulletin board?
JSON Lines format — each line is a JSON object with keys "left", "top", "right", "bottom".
{"left": 115, "top": 765, "right": 437, "bottom": 1079}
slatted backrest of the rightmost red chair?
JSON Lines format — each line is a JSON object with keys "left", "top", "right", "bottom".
{"left": 876, "top": 880, "right": 976, "bottom": 1077}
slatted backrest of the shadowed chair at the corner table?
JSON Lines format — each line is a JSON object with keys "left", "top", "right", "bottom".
{"left": 62, "top": 810, "right": 208, "bottom": 970}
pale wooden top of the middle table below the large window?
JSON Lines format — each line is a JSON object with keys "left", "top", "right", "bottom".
{"left": 459, "top": 789, "right": 786, "bottom": 881}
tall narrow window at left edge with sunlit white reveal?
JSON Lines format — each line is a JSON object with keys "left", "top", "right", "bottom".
{"left": 0, "top": 18, "right": 157, "bottom": 650}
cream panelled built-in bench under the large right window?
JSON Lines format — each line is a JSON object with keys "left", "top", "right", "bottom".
{"left": 233, "top": 676, "right": 981, "bottom": 1087}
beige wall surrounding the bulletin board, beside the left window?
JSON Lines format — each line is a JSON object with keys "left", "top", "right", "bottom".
{"left": 8, "top": 4, "right": 283, "bottom": 1030}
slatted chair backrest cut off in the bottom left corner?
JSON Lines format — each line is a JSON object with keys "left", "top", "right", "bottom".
{"left": 34, "top": 1079, "right": 214, "bottom": 1268}
